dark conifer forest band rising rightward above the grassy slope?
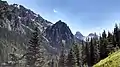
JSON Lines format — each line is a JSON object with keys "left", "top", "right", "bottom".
{"left": 61, "top": 24, "right": 120, "bottom": 67}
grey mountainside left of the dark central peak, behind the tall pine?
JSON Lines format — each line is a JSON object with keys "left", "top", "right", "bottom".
{"left": 0, "top": 0, "right": 54, "bottom": 67}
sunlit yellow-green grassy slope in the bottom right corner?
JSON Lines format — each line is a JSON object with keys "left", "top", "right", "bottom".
{"left": 93, "top": 50, "right": 120, "bottom": 67}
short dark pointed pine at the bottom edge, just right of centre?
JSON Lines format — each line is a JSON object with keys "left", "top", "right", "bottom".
{"left": 66, "top": 49, "right": 75, "bottom": 67}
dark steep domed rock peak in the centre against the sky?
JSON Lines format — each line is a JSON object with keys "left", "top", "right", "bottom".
{"left": 46, "top": 20, "right": 74, "bottom": 48}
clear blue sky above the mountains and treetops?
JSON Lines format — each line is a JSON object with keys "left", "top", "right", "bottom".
{"left": 6, "top": 0, "right": 120, "bottom": 36}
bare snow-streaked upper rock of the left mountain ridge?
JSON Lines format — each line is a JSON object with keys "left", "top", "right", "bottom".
{"left": 0, "top": 1, "right": 52, "bottom": 34}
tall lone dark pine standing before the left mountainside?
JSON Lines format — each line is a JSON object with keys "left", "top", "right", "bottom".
{"left": 26, "top": 27, "right": 40, "bottom": 67}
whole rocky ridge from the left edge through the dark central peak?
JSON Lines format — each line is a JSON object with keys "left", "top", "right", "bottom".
{"left": 0, "top": 0, "right": 74, "bottom": 63}
